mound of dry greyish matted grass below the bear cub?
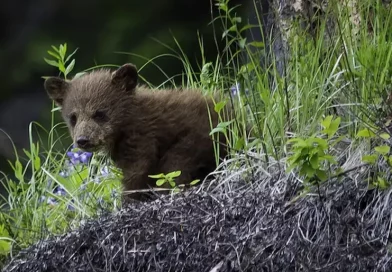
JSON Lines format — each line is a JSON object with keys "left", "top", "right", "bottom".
{"left": 3, "top": 150, "right": 392, "bottom": 272}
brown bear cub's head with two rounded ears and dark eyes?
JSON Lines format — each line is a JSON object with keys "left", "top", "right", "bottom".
{"left": 44, "top": 63, "right": 138, "bottom": 152}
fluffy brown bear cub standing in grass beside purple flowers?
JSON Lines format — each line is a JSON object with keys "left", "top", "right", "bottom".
{"left": 44, "top": 64, "right": 227, "bottom": 199}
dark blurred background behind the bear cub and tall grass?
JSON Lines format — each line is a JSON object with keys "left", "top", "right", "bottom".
{"left": 0, "top": 0, "right": 267, "bottom": 183}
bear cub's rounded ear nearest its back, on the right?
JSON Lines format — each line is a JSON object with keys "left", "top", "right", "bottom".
{"left": 112, "top": 63, "right": 138, "bottom": 91}
